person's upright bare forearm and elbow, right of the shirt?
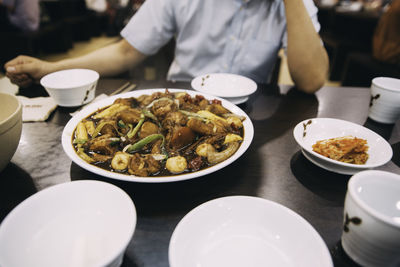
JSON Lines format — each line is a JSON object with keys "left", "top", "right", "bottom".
{"left": 284, "top": 0, "right": 329, "bottom": 93}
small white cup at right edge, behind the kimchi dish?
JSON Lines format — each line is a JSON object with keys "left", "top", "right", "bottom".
{"left": 368, "top": 77, "right": 400, "bottom": 124}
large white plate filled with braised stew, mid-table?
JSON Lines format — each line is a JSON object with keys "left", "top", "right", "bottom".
{"left": 62, "top": 88, "right": 254, "bottom": 183}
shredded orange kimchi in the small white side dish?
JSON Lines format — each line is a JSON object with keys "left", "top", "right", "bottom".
{"left": 312, "top": 136, "right": 368, "bottom": 164}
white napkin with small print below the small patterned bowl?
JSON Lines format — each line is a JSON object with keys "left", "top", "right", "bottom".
{"left": 17, "top": 96, "right": 57, "bottom": 122}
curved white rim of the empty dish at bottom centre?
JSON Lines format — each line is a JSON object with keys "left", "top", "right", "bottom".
{"left": 168, "top": 195, "right": 333, "bottom": 267}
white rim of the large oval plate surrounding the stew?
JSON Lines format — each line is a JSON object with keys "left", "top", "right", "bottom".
{"left": 61, "top": 88, "right": 254, "bottom": 183}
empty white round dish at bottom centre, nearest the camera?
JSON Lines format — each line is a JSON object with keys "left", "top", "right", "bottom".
{"left": 168, "top": 196, "right": 333, "bottom": 267}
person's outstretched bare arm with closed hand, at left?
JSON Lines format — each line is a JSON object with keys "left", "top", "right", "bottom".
{"left": 4, "top": 39, "right": 146, "bottom": 87}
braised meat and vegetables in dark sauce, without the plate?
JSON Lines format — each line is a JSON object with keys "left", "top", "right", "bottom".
{"left": 72, "top": 90, "right": 245, "bottom": 177}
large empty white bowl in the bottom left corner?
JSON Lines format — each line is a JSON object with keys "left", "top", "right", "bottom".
{"left": 0, "top": 180, "right": 136, "bottom": 267}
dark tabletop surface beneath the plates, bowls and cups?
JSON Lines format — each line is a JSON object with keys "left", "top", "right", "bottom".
{"left": 0, "top": 79, "right": 400, "bottom": 266}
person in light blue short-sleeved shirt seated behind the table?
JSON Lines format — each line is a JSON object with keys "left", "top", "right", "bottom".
{"left": 5, "top": 0, "right": 329, "bottom": 93}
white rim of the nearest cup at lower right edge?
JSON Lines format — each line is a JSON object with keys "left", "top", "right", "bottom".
{"left": 347, "top": 170, "right": 400, "bottom": 229}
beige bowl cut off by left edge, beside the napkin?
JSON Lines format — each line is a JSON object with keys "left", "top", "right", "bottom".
{"left": 0, "top": 93, "right": 22, "bottom": 172}
